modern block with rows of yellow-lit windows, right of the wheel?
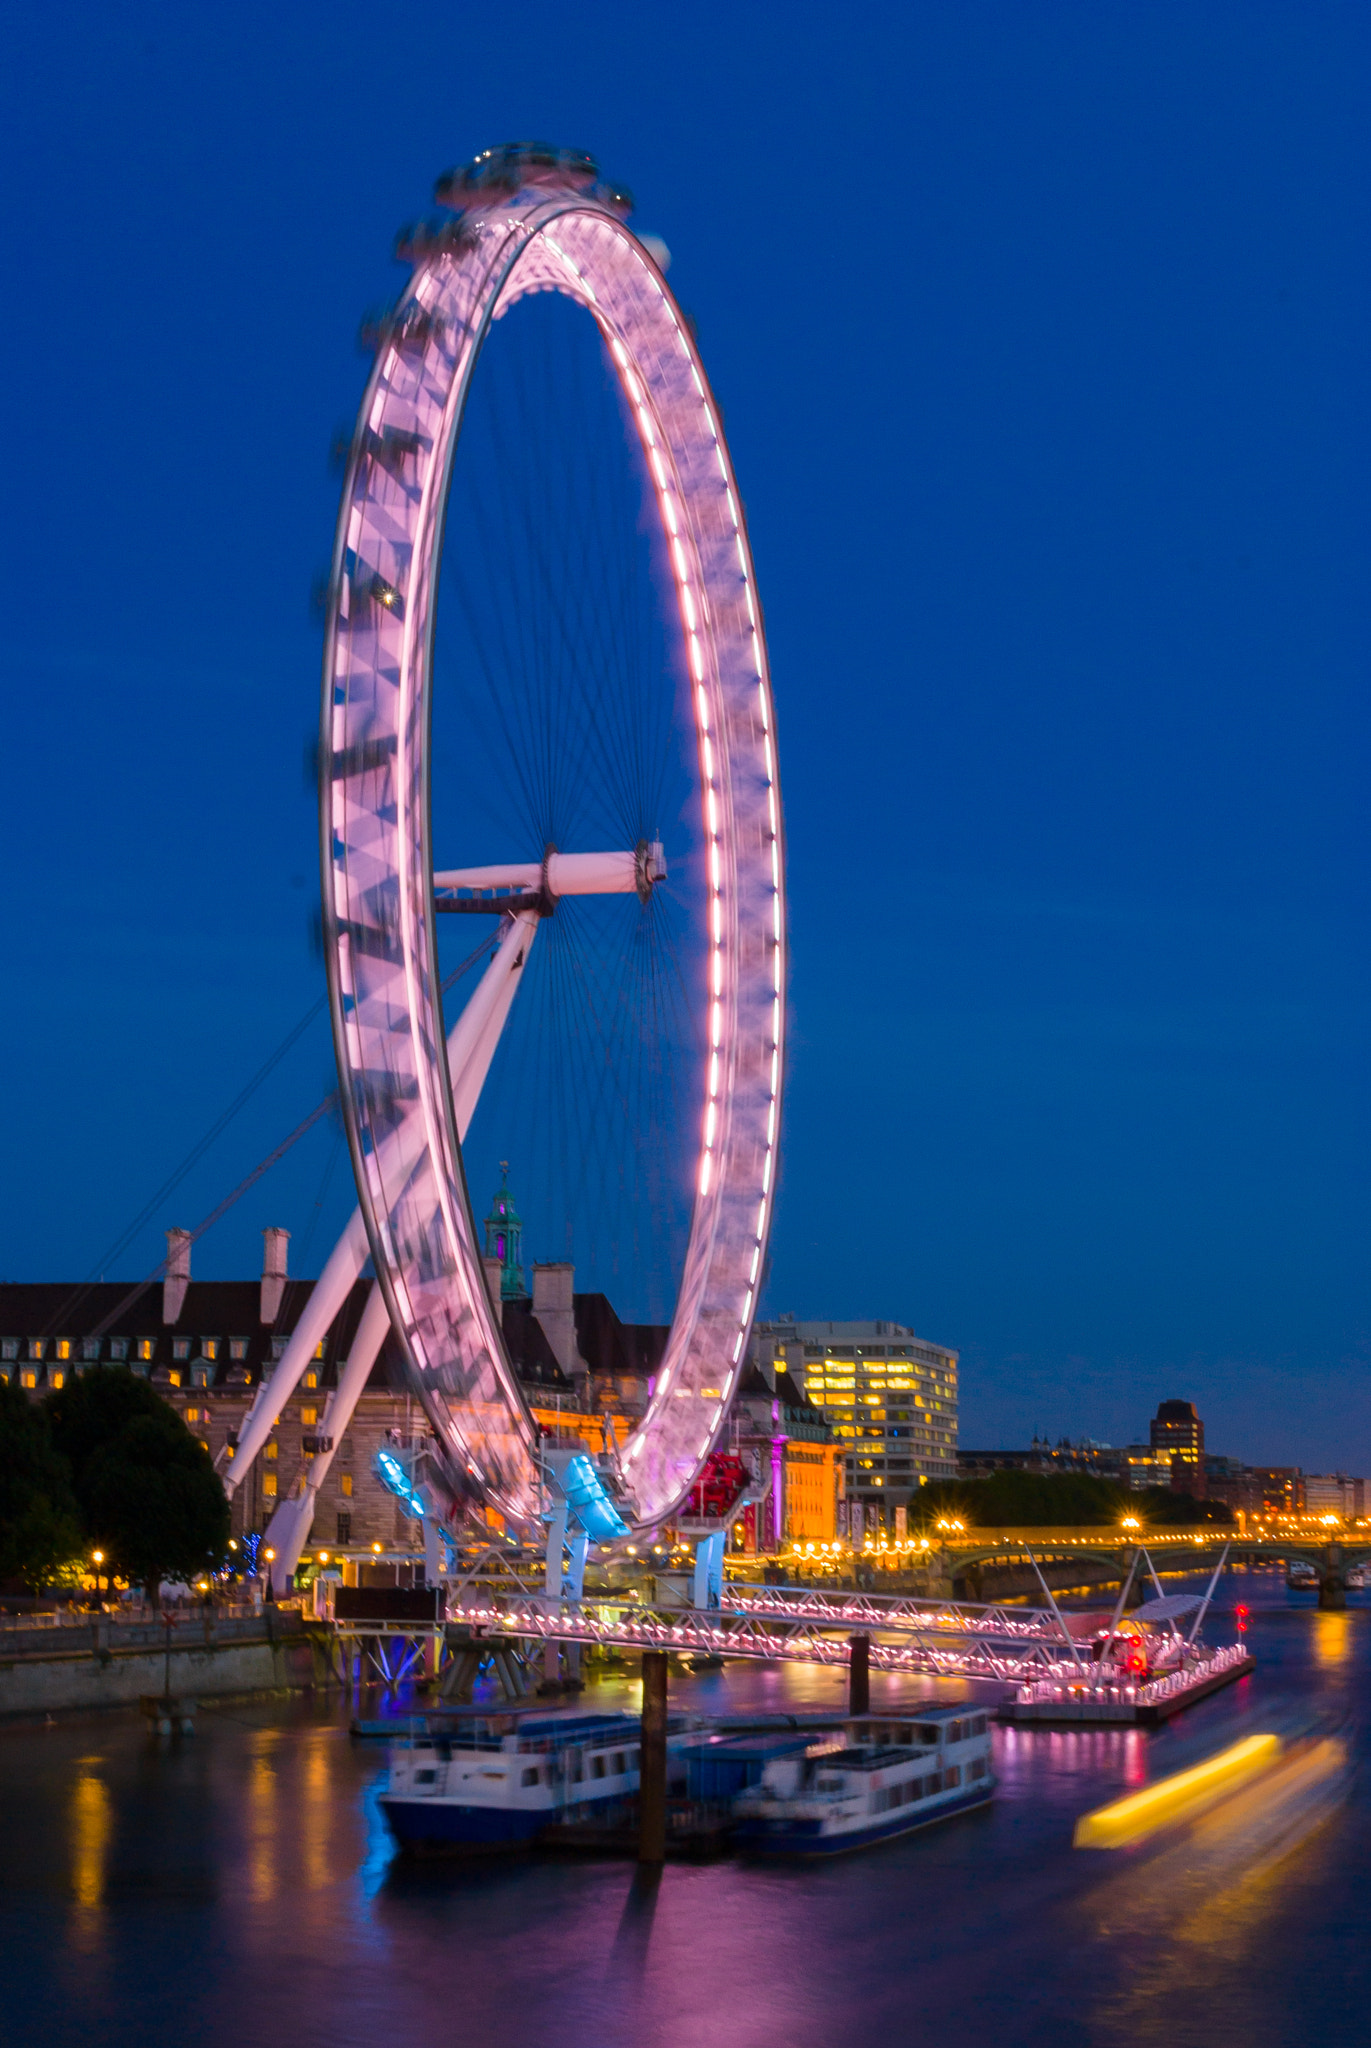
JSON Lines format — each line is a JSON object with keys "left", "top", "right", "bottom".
{"left": 752, "top": 1317, "right": 957, "bottom": 1526}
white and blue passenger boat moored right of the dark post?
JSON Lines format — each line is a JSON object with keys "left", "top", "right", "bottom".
{"left": 734, "top": 1706, "right": 996, "bottom": 1855}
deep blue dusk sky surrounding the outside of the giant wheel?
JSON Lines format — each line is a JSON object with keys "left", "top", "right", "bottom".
{"left": 0, "top": 0, "right": 1371, "bottom": 1473}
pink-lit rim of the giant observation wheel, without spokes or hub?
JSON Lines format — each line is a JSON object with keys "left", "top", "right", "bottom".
{"left": 320, "top": 172, "right": 785, "bottom": 1530}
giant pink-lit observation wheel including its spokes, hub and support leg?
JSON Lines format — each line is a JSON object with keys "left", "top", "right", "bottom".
{"left": 224, "top": 145, "right": 785, "bottom": 1532}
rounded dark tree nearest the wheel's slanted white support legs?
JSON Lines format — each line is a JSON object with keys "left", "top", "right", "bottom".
{"left": 49, "top": 1366, "right": 230, "bottom": 1606}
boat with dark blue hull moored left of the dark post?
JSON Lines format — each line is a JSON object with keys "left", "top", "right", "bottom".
{"left": 381, "top": 1708, "right": 641, "bottom": 1851}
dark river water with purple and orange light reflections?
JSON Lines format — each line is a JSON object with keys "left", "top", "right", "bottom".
{"left": 0, "top": 1571, "right": 1371, "bottom": 2048}
